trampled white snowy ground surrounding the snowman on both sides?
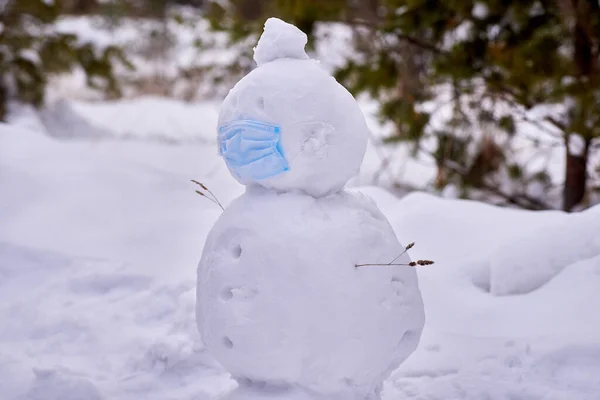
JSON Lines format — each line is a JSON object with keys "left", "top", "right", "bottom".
{"left": 0, "top": 100, "right": 600, "bottom": 400}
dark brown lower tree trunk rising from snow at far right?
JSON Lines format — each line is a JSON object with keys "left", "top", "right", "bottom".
{"left": 563, "top": 139, "right": 591, "bottom": 211}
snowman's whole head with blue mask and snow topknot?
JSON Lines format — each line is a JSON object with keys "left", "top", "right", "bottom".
{"left": 218, "top": 18, "right": 369, "bottom": 197}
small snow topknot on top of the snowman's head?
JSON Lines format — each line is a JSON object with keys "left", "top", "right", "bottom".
{"left": 254, "top": 18, "right": 308, "bottom": 66}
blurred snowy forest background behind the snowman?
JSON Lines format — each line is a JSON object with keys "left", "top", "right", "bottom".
{"left": 0, "top": 0, "right": 600, "bottom": 211}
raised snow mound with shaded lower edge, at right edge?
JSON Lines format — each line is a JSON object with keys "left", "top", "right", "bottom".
{"left": 489, "top": 206, "right": 600, "bottom": 295}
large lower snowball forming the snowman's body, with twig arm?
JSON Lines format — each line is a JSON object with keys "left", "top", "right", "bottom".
{"left": 196, "top": 187, "right": 424, "bottom": 398}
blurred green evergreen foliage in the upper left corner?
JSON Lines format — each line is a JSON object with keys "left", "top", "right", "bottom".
{"left": 0, "top": 0, "right": 131, "bottom": 120}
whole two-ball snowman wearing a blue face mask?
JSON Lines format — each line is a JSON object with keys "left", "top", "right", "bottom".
{"left": 196, "top": 18, "right": 424, "bottom": 400}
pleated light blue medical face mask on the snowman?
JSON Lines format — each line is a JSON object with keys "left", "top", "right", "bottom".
{"left": 219, "top": 119, "right": 290, "bottom": 182}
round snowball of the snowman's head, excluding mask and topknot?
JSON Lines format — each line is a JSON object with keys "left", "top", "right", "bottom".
{"left": 218, "top": 59, "right": 369, "bottom": 196}
